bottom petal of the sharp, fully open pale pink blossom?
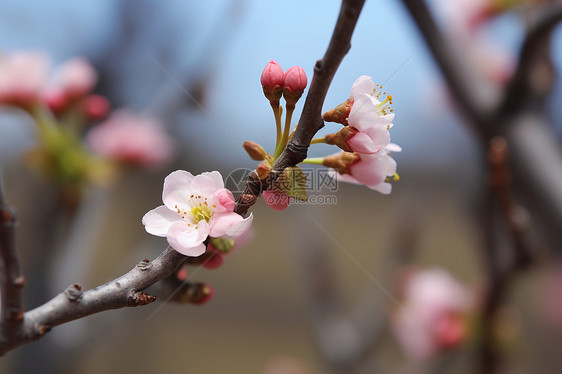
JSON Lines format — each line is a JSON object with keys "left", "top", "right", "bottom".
{"left": 168, "top": 220, "right": 209, "bottom": 257}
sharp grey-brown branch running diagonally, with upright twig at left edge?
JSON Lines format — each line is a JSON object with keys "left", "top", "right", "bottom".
{"left": 0, "top": 0, "right": 364, "bottom": 355}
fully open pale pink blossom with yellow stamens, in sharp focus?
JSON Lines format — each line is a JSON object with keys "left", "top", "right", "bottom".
{"left": 142, "top": 170, "right": 253, "bottom": 257}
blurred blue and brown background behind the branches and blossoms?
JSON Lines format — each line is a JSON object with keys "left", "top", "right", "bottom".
{"left": 0, "top": 0, "right": 562, "bottom": 374}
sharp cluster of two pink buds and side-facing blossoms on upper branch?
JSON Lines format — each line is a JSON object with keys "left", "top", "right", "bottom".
{"left": 244, "top": 60, "right": 401, "bottom": 210}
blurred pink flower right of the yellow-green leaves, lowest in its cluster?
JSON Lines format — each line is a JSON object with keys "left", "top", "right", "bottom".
{"left": 86, "top": 109, "right": 173, "bottom": 166}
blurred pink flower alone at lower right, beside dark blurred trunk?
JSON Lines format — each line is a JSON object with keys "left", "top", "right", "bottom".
{"left": 392, "top": 269, "right": 472, "bottom": 360}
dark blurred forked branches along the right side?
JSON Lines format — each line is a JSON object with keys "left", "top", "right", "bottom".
{"left": 403, "top": 0, "right": 562, "bottom": 373}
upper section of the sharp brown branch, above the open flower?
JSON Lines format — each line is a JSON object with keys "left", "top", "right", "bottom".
{"left": 234, "top": 0, "right": 365, "bottom": 214}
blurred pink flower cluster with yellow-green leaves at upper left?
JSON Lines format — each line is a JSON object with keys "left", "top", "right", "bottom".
{"left": 0, "top": 51, "right": 173, "bottom": 195}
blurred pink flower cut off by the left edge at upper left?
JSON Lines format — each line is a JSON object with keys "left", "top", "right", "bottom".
{"left": 0, "top": 52, "right": 49, "bottom": 109}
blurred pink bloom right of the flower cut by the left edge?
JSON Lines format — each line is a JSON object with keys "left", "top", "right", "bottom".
{"left": 52, "top": 57, "right": 98, "bottom": 101}
